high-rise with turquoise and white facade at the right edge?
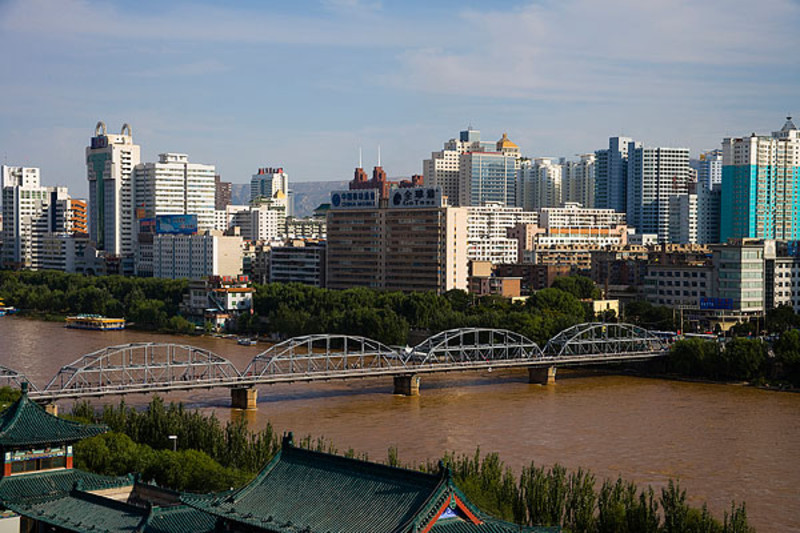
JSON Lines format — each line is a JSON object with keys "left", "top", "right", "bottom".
{"left": 720, "top": 117, "right": 800, "bottom": 242}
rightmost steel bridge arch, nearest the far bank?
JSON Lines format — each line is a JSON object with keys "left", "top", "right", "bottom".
{"left": 544, "top": 322, "right": 669, "bottom": 357}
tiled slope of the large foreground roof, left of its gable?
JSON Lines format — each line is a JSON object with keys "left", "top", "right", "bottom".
{"left": 182, "top": 436, "right": 443, "bottom": 533}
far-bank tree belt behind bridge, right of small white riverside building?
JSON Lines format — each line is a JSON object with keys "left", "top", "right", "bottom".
{"left": 247, "top": 276, "right": 597, "bottom": 345}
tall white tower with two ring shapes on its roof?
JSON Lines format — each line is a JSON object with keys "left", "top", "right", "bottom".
{"left": 86, "top": 122, "right": 141, "bottom": 257}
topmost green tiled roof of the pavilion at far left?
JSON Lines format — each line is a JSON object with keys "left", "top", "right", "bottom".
{"left": 0, "top": 393, "right": 108, "bottom": 448}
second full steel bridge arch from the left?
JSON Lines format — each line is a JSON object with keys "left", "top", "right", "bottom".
{"left": 242, "top": 334, "right": 404, "bottom": 381}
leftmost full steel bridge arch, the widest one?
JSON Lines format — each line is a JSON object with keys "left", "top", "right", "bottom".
{"left": 43, "top": 342, "right": 240, "bottom": 393}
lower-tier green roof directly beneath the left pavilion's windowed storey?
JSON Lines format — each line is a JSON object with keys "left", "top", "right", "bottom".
{"left": 0, "top": 468, "right": 133, "bottom": 504}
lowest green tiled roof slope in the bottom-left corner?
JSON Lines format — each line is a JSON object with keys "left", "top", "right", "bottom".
{"left": 5, "top": 490, "right": 149, "bottom": 533}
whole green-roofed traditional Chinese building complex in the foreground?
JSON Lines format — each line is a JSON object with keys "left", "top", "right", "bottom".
{"left": 0, "top": 387, "right": 558, "bottom": 533}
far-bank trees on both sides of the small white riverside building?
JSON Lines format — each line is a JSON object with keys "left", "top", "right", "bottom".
{"left": 0, "top": 271, "right": 597, "bottom": 345}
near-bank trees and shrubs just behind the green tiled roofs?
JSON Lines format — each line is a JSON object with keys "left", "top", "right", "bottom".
{"left": 65, "top": 397, "right": 753, "bottom": 533}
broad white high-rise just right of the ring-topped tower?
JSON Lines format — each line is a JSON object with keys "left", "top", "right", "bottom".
{"left": 134, "top": 153, "right": 216, "bottom": 231}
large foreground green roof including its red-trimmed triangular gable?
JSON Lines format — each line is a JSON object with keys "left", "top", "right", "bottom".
{"left": 181, "top": 437, "right": 558, "bottom": 533}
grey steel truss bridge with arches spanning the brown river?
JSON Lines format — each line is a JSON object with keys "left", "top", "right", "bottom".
{"left": 18, "top": 322, "right": 668, "bottom": 402}
